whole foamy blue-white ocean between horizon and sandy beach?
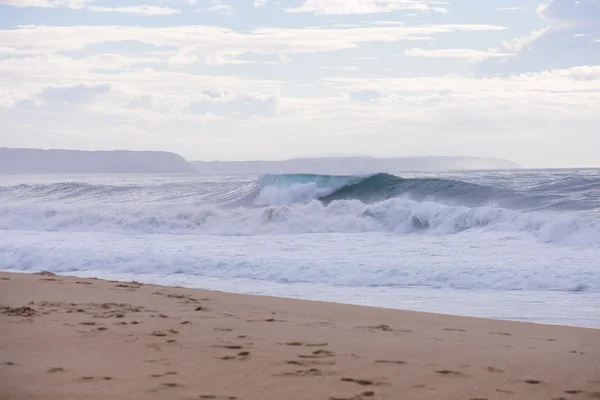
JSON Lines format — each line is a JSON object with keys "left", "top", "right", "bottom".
{"left": 0, "top": 169, "right": 600, "bottom": 328}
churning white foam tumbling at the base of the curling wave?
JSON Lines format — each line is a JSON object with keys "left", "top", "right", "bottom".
{"left": 0, "top": 199, "right": 600, "bottom": 245}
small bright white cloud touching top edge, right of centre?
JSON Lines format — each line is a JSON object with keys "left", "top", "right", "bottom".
{"left": 286, "top": 0, "right": 448, "bottom": 15}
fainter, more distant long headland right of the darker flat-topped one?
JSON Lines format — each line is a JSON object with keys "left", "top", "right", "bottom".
{"left": 191, "top": 156, "right": 521, "bottom": 175}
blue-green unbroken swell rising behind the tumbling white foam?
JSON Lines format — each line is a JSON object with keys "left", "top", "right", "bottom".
{"left": 0, "top": 173, "right": 600, "bottom": 212}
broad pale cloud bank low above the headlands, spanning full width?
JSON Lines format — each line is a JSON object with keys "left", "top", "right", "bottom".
{"left": 0, "top": 65, "right": 600, "bottom": 166}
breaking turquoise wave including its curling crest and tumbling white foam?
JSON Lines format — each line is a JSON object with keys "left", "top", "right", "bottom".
{"left": 0, "top": 174, "right": 600, "bottom": 245}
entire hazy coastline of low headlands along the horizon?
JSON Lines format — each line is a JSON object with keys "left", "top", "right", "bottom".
{"left": 0, "top": 148, "right": 522, "bottom": 175}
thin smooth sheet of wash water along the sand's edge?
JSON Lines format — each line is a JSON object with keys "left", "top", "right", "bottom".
{"left": 5, "top": 270, "right": 600, "bottom": 329}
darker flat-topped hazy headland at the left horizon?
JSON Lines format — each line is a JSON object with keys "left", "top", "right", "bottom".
{"left": 0, "top": 148, "right": 197, "bottom": 174}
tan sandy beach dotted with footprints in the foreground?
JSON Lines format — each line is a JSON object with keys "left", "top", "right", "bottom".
{"left": 0, "top": 273, "right": 600, "bottom": 400}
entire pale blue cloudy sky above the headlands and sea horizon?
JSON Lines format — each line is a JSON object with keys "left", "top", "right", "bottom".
{"left": 0, "top": 0, "right": 600, "bottom": 168}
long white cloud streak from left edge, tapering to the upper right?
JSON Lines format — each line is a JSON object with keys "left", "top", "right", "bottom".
{"left": 0, "top": 25, "right": 506, "bottom": 65}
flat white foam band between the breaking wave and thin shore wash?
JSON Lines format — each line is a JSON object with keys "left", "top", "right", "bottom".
{"left": 0, "top": 231, "right": 600, "bottom": 292}
